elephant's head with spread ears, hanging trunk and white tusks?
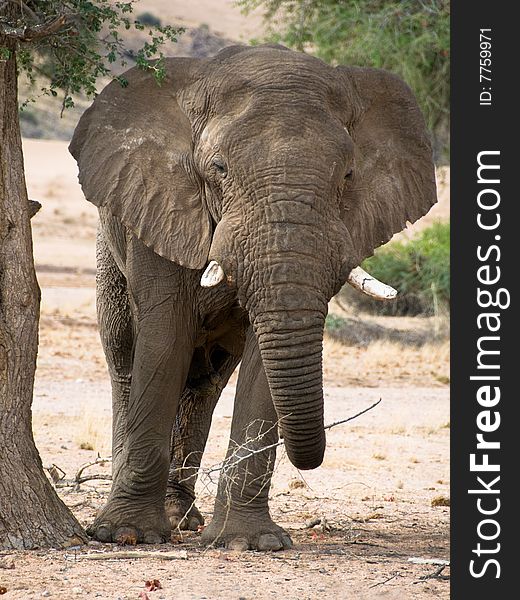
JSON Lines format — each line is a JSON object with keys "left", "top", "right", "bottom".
{"left": 70, "top": 46, "right": 436, "bottom": 469}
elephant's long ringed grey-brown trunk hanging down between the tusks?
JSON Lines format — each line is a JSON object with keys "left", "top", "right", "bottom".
{"left": 243, "top": 223, "right": 331, "bottom": 469}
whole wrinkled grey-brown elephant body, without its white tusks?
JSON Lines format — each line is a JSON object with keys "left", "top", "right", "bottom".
{"left": 70, "top": 46, "right": 435, "bottom": 550}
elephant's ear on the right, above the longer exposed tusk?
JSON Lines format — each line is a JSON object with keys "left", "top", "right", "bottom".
{"left": 336, "top": 67, "right": 437, "bottom": 262}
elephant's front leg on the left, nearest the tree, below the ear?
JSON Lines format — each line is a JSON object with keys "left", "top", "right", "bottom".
{"left": 87, "top": 241, "right": 195, "bottom": 543}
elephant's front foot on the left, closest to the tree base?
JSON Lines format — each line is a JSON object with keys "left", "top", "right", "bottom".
{"left": 87, "top": 503, "right": 171, "bottom": 545}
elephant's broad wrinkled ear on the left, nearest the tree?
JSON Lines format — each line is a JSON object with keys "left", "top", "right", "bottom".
{"left": 69, "top": 58, "right": 211, "bottom": 269}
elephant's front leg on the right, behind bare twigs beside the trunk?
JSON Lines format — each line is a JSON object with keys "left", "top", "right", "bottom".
{"left": 202, "top": 331, "right": 292, "bottom": 550}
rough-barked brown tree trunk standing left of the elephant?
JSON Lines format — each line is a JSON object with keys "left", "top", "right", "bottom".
{"left": 0, "top": 28, "right": 85, "bottom": 549}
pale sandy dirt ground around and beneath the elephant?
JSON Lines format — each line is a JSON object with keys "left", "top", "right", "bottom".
{"left": 0, "top": 140, "right": 450, "bottom": 600}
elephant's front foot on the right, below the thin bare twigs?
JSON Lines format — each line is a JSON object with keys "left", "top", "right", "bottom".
{"left": 201, "top": 514, "right": 293, "bottom": 552}
